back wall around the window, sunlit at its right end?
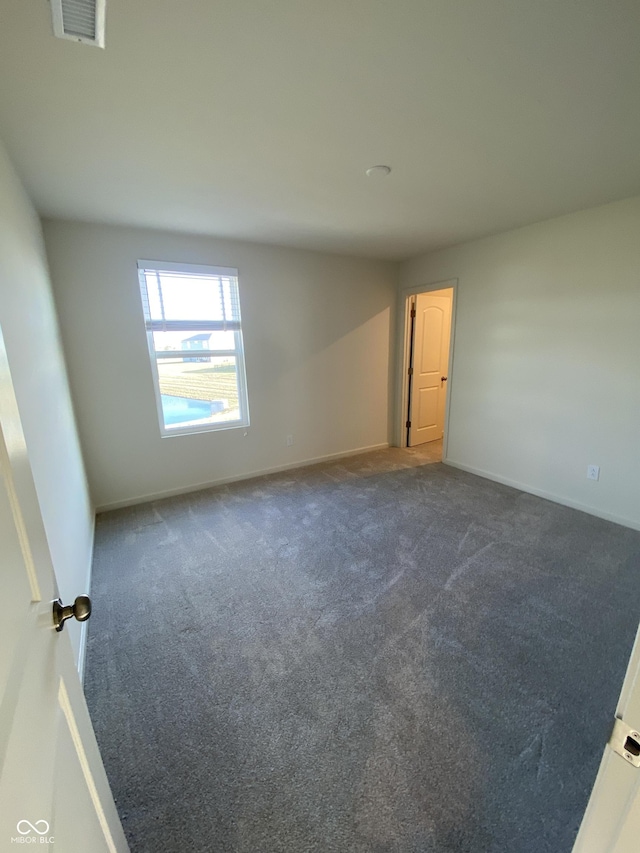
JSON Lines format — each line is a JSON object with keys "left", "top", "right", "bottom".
{"left": 44, "top": 220, "right": 397, "bottom": 508}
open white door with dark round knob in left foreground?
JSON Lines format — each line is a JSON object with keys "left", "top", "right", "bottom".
{"left": 0, "top": 333, "right": 128, "bottom": 853}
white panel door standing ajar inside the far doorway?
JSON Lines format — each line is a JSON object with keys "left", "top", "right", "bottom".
{"left": 408, "top": 288, "right": 453, "bottom": 447}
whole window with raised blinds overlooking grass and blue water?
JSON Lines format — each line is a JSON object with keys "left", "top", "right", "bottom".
{"left": 138, "top": 261, "right": 249, "bottom": 436}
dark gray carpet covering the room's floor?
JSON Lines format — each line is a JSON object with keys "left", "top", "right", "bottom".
{"left": 86, "top": 450, "right": 640, "bottom": 853}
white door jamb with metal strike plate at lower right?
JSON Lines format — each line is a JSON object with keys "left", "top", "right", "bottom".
{"left": 573, "top": 629, "right": 640, "bottom": 853}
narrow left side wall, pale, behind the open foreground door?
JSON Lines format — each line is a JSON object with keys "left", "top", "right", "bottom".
{"left": 0, "top": 140, "right": 93, "bottom": 662}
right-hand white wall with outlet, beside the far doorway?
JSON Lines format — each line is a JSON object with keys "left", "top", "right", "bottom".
{"left": 401, "top": 198, "right": 640, "bottom": 527}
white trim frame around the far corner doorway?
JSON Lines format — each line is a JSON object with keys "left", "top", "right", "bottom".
{"left": 394, "top": 278, "right": 458, "bottom": 452}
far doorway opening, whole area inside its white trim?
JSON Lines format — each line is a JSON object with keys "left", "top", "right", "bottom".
{"left": 402, "top": 282, "right": 454, "bottom": 458}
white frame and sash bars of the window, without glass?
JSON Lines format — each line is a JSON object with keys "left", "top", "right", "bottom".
{"left": 137, "top": 260, "right": 250, "bottom": 438}
